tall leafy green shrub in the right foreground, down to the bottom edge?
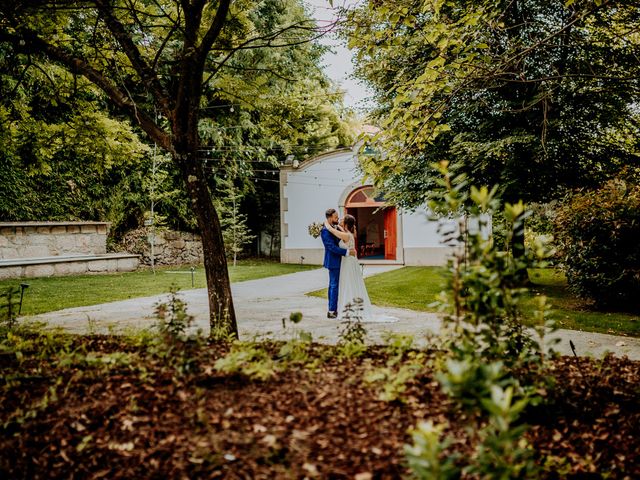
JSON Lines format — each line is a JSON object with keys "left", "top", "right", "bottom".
{"left": 405, "top": 162, "right": 553, "bottom": 479}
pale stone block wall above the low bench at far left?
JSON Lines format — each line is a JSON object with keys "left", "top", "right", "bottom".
{"left": 0, "top": 222, "right": 109, "bottom": 260}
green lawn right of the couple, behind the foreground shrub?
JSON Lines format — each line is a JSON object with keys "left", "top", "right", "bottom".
{"left": 310, "top": 267, "right": 640, "bottom": 337}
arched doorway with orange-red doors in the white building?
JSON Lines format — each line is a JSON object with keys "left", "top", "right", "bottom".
{"left": 345, "top": 186, "right": 398, "bottom": 260}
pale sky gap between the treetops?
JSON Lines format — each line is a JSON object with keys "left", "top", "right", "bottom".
{"left": 304, "top": 0, "right": 370, "bottom": 113}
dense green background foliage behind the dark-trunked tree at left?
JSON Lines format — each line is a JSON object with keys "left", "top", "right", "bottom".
{"left": 0, "top": 0, "right": 354, "bottom": 244}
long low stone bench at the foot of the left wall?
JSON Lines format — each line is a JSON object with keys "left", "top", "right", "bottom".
{"left": 0, "top": 253, "right": 140, "bottom": 279}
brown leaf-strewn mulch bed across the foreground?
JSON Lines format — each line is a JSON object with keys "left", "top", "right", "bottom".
{"left": 0, "top": 337, "right": 640, "bottom": 479}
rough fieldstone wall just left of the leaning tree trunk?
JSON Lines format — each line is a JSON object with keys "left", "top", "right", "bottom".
{"left": 120, "top": 228, "right": 204, "bottom": 265}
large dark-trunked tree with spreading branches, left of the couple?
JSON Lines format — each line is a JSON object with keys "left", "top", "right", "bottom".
{"left": 0, "top": 0, "right": 342, "bottom": 334}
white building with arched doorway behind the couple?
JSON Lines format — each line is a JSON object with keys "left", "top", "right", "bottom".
{"left": 280, "top": 147, "right": 460, "bottom": 265}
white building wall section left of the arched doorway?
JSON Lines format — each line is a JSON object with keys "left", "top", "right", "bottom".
{"left": 282, "top": 151, "right": 362, "bottom": 249}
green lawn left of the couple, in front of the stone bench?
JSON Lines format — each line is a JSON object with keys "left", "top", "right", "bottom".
{"left": 0, "top": 259, "right": 318, "bottom": 315}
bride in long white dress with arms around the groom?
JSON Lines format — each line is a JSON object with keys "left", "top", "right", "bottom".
{"left": 324, "top": 214, "right": 397, "bottom": 322}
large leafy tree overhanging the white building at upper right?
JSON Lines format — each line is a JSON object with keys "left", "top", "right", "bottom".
{"left": 348, "top": 0, "right": 640, "bottom": 206}
